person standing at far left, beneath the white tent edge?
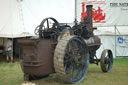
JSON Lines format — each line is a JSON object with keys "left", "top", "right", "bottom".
{"left": 4, "top": 39, "right": 14, "bottom": 63}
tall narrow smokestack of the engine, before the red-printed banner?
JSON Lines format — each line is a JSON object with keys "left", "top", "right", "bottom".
{"left": 86, "top": 5, "right": 93, "bottom": 34}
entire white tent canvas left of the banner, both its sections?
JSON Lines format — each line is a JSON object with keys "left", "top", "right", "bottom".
{"left": 0, "top": 0, "right": 75, "bottom": 38}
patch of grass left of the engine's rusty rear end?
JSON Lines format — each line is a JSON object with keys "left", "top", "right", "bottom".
{"left": 0, "top": 62, "right": 24, "bottom": 85}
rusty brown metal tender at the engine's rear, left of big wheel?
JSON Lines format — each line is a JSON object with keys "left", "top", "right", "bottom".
{"left": 18, "top": 39, "right": 55, "bottom": 77}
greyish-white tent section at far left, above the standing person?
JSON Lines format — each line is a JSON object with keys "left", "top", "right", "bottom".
{"left": 0, "top": 0, "right": 33, "bottom": 38}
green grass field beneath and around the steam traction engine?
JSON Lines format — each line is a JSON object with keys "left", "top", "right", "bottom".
{"left": 0, "top": 58, "right": 128, "bottom": 85}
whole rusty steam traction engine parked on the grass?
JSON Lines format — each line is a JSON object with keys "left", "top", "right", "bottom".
{"left": 19, "top": 5, "right": 113, "bottom": 83}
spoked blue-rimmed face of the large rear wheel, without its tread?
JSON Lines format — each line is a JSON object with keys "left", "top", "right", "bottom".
{"left": 64, "top": 37, "right": 89, "bottom": 83}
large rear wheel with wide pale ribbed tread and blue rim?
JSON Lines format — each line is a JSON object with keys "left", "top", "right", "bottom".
{"left": 54, "top": 36, "right": 89, "bottom": 83}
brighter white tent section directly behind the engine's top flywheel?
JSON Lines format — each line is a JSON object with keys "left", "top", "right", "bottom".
{"left": 21, "top": 0, "right": 75, "bottom": 33}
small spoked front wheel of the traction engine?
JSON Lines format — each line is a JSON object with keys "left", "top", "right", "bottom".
{"left": 100, "top": 49, "right": 113, "bottom": 72}
